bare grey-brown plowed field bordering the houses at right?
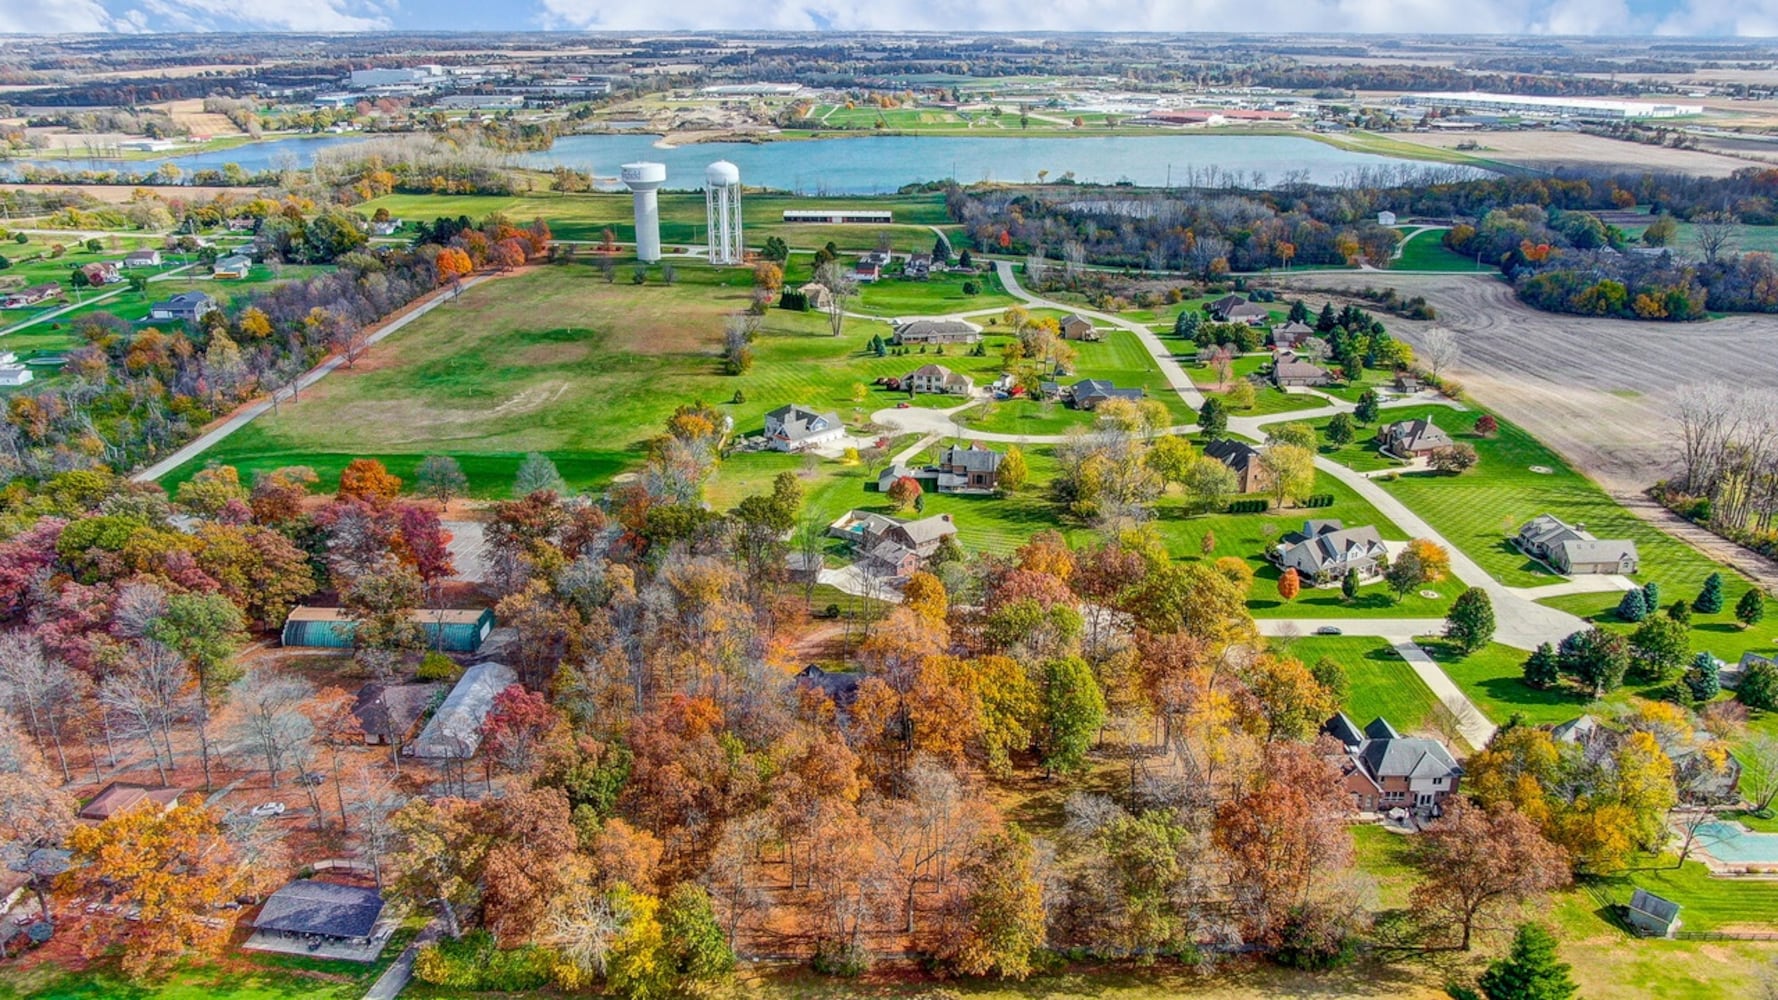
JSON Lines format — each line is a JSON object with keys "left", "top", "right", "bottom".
{"left": 1280, "top": 272, "right": 1778, "bottom": 493}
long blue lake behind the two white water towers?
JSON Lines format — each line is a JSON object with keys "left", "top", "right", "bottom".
{"left": 6, "top": 133, "right": 1481, "bottom": 194}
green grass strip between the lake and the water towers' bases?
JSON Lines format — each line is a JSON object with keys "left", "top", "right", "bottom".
{"left": 359, "top": 190, "right": 951, "bottom": 251}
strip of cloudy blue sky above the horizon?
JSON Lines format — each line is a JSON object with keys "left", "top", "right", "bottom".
{"left": 0, "top": 0, "right": 1778, "bottom": 37}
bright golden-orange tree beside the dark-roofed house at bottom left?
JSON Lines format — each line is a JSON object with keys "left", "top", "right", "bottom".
{"left": 66, "top": 797, "right": 245, "bottom": 979}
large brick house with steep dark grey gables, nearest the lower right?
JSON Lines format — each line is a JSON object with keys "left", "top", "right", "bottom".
{"left": 1321, "top": 712, "right": 1463, "bottom": 815}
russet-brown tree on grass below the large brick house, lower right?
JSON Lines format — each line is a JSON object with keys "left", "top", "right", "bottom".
{"left": 1414, "top": 797, "right": 1568, "bottom": 952}
